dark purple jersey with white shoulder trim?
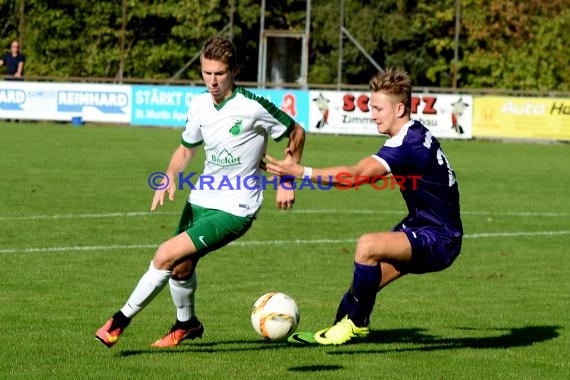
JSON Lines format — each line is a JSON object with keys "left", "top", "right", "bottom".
{"left": 376, "top": 121, "right": 463, "bottom": 238}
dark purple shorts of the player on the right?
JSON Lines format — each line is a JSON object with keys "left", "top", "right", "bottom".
{"left": 394, "top": 224, "right": 462, "bottom": 274}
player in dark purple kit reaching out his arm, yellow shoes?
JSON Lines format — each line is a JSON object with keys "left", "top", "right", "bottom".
{"left": 266, "top": 69, "right": 463, "bottom": 345}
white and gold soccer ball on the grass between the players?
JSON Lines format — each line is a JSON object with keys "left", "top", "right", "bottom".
{"left": 251, "top": 292, "right": 301, "bottom": 342}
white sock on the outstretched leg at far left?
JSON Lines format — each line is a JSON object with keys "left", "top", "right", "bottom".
{"left": 121, "top": 261, "right": 172, "bottom": 318}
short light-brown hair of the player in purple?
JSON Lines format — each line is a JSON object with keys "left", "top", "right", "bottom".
{"left": 368, "top": 68, "right": 412, "bottom": 115}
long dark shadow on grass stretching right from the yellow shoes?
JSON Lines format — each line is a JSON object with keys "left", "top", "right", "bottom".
{"left": 329, "top": 326, "right": 561, "bottom": 355}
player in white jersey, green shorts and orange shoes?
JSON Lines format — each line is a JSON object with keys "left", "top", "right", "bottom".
{"left": 95, "top": 37, "right": 305, "bottom": 347}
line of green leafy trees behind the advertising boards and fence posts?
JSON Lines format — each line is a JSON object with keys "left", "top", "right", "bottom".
{"left": 0, "top": 0, "right": 570, "bottom": 92}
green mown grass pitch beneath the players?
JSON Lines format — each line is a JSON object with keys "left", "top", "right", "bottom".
{"left": 0, "top": 122, "right": 570, "bottom": 379}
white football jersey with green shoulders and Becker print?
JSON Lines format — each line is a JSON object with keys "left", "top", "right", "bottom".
{"left": 182, "top": 87, "right": 295, "bottom": 216}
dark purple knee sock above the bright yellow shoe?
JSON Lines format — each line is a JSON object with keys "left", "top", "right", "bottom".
{"left": 348, "top": 263, "right": 382, "bottom": 327}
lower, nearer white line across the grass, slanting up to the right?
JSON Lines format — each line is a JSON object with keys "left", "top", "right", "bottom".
{"left": 0, "top": 231, "right": 570, "bottom": 254}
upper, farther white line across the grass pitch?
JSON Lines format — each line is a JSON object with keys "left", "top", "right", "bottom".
{"left": 0, "top": 209, "right": 570, "bottom": 222}
